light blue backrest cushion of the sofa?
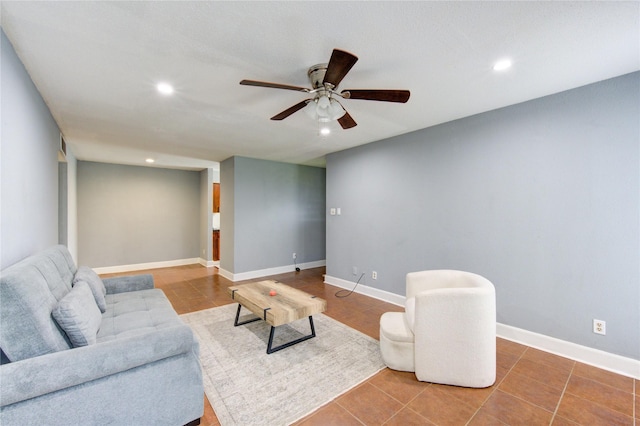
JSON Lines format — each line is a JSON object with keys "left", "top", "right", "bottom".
{"left": 0, "top": 246, "right": 76, "bottom": 362}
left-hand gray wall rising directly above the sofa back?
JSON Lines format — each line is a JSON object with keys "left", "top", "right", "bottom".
{"left": 0, "top": 32, "right": 60, "bottom": 268}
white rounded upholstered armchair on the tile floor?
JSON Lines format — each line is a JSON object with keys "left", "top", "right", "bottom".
{"left": 380, "top": 270, "right": 496, "bottom": 388}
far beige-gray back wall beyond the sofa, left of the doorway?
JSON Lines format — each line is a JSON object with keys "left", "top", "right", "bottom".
{"left": 77, "top": 161, "right": 204, "bottom": 268}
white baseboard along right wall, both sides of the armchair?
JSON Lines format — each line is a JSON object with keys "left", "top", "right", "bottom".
{"left": 324, "top": 275, "right": 640, "bottom": 380}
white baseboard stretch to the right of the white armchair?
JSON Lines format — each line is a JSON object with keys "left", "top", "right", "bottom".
{"left": 496, "top": 323, "right": 640, "bottom": 379}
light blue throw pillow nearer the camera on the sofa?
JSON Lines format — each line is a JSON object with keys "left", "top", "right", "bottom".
{"left": 51, "top": 281, "right": 102, "bottom": 347}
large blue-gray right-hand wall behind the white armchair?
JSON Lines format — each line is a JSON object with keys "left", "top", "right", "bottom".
{"left": 327, "top": 73, "right": 640, "bottom": 359}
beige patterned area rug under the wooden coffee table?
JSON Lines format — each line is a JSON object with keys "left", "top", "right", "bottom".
{"left": 180, "top": 304, "right": 384, "bottom": 426}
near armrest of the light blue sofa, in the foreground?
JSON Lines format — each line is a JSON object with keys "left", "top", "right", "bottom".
{"left": 0, "top": 324, "right": 198, "bottom": 406}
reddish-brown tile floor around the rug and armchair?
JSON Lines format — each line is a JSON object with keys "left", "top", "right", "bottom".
{"left": 104, "top": 265, "right": 640, "bottom": 426}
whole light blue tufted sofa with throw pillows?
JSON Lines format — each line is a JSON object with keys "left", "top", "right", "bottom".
{"left": 0, "top": 246, "right": 204, "bottom": 426}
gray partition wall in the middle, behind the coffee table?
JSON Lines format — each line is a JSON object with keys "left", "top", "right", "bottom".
{"left": 220, "top": 157, "right": 326, "bottom": 273}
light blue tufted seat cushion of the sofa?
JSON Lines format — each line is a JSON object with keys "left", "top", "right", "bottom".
{"left": 97, "top": 289, "right": 182, "bottom": 343}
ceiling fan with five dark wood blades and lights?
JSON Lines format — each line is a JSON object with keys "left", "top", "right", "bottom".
{"left": 240, "top": 49, "right": 410, "bottom": 129}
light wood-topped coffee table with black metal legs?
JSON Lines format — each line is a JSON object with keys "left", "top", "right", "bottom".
{"left": 227, "top": 280, "right": 327, "bottom": 354}
